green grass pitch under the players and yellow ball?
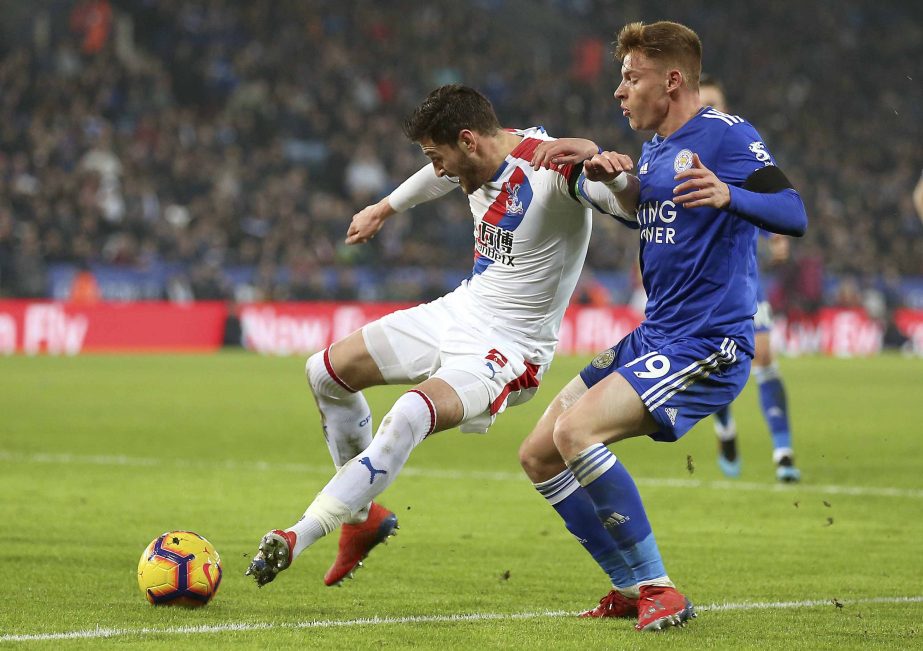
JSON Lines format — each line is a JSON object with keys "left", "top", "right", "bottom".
{"left": 0, "top": 353, "right": 923, "bottom": 650}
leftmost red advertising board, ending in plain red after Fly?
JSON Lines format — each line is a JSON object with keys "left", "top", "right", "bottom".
{"left": 0, "top": 301, "right": 227, "bottom": 355}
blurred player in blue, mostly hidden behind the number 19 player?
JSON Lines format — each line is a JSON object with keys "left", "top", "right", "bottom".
{"left": 699, "top": 75, "right": 801, "bottom": 482}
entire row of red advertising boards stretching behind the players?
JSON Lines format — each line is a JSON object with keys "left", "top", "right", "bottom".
{"left": 0, "top": 301, "right": 923, "bottom": 357}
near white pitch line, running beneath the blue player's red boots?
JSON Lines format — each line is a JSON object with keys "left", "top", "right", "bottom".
{"left": 0, "top": 595, "right": 923, "bottom": 642}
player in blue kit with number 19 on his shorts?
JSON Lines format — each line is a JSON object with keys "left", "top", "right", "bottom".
{"left": 520, "top": 22, "right": 807, "bottom": 630}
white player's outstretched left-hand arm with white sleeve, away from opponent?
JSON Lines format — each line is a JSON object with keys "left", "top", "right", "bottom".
{"left": 346, "top": 165, "right": 458, "bottom": 244}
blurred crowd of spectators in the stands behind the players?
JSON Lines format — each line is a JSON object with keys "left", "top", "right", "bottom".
{"left": 0, "top": 0, "right": 923, "bottom": 316}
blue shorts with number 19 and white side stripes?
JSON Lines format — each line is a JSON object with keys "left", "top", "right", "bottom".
{"left": 580, "top": 326, "right": 751, "bottom": 441}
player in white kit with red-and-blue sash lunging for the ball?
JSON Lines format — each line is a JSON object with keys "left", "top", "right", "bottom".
{"left": 247, "top": 84, "right": 636, "bottom": 585}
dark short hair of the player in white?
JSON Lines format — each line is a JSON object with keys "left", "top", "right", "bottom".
{"left": 403, "top": 84, "right": 500, "bottom": 145}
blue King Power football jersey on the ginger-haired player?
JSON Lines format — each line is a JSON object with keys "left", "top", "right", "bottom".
{"left": 637, "top": 107, "right": 775, "bottom": 354}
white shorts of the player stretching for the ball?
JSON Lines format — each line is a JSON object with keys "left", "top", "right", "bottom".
{"left": 362, "top": 287, "right": 548, "bottom": 433}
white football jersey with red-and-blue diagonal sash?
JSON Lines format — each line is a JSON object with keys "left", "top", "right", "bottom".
{"left": 389, "top": 127, "right": 591, "bottom": 364}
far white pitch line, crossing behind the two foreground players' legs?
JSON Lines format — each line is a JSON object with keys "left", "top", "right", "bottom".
{"left": 0, "top": 450, "right": 923, "bottom": 499}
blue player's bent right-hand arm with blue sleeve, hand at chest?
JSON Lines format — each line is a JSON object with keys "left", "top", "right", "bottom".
{"left": 673, "top": 153, "right": 808, "bottom": 237}
